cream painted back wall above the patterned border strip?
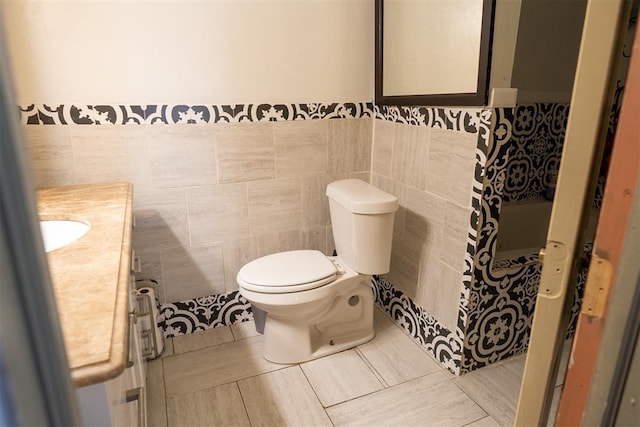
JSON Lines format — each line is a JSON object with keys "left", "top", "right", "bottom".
{"left": 2, "top": 0, "right": 374, "bottom": 104}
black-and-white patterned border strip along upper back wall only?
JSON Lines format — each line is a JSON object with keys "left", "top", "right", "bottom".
{"left": 20, "top": 102, "right": 375, "bottom": 125}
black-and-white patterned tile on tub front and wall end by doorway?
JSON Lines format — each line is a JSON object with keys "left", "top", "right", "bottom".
{"left": 460, "top": 108, "right": 588, "bottom": 373}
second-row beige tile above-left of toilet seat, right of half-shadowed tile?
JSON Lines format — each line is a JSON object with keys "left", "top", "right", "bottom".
{"left": 186, "top": 183, "right": 249, "bottom": 244}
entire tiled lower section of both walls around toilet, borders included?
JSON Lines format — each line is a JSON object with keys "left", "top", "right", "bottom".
{"left": 22, "top": 103, "right": 491, "bottom": 373}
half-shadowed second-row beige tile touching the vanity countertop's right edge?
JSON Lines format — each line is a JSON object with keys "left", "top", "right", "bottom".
{"left": 133, "top": 188, "right": 189, "bottom": 251}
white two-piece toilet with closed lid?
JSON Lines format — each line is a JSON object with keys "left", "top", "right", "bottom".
{"left": 237, "top": 179, "right": 398, "bottom": 364}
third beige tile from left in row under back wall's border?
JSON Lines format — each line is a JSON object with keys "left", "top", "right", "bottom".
{"left": 149, "top": 124, "right": 217, "bottom": 188}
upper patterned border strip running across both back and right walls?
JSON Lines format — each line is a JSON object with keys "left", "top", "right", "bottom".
{"left": 20, "top": 102, "right": 488, "bottom": 133}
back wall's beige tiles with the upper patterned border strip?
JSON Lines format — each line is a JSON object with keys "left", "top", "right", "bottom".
{"left": 22, "top": 104, "right": 372, "bottom": 303}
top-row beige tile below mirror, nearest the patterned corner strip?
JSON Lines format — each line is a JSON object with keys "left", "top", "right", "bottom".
{"left": 425, "top": 128, "right": 478, "bottom": 206}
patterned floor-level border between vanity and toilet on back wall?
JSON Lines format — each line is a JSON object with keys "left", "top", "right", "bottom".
{"left": 159, "top": 291, "right": 253, "bottom": 338}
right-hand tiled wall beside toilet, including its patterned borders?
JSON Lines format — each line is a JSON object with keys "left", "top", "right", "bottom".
{"left": 364, "top": 107, "right": 492, "bottom": 374}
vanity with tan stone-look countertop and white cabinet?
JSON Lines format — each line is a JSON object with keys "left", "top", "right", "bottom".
{"left": 37, "top": 183, "right": 146, "bottom": 426}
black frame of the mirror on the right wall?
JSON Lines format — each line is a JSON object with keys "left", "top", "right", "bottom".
{"left": 375, "top": 0, "right": 494, "bottom": 106}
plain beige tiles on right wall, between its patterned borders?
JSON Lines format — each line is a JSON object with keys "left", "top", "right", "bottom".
{"left": 371, "top": 119, "right": 478, "bottom": 331}
